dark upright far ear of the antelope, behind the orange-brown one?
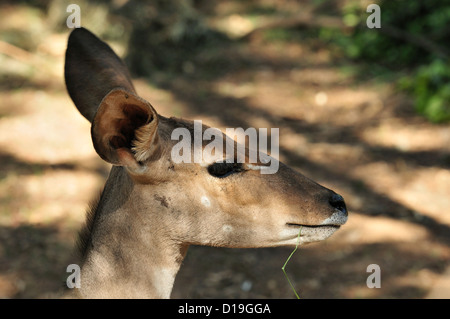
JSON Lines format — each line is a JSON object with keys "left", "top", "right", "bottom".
{"left": 64, "top": 28, "right": 135, "bottom": 122}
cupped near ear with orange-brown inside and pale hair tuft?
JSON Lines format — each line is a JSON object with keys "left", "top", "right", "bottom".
{"left": 91, "top": 88, "right": 160, "bottom": 172}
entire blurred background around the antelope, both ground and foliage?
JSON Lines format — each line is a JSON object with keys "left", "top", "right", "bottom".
{"left": 0, "top": 0, "right": 450, "bottom": 298}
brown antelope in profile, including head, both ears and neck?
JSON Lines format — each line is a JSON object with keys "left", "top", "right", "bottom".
{"left": 65, "top": 28, "right": 347, "bottom": 297}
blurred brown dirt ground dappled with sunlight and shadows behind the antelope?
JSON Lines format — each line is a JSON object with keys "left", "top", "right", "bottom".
{"left": 0, "top": 1, "right": 450, "bottom": 298}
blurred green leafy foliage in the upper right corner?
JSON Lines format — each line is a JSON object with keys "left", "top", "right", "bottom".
{"left": 328, "top": 0, "right": 450, "bottom": 122}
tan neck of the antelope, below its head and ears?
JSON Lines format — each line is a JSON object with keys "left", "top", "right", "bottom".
{"left": 74, "top": 168, "right": 187, "bottom": 298}
